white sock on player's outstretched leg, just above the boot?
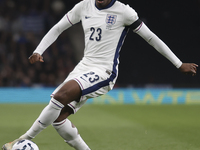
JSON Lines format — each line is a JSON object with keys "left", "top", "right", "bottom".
{"left": 24, "top": 98, "right": 64, "bottom": 139}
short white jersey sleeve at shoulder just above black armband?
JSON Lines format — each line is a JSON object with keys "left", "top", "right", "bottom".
{"left": 124, "top": 5, "right": 139, "bottom": 26}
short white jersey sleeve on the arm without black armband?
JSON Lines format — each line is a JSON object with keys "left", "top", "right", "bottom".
{"left": 67, "top": 1, "right": 84, "bottom": 25}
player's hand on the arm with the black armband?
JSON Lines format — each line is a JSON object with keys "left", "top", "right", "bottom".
{"left": 179, "top": 63, "right": 198, "bottom": 76}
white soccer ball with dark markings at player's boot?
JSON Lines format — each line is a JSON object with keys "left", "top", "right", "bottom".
{"left": 12, "top": 140, "right": 39, "bottom": 150}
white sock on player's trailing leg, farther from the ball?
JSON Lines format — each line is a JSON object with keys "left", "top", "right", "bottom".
{"left": 52, "top": 119, "right": 90, "bottom": 150}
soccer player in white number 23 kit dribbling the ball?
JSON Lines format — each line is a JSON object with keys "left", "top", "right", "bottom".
{"left": 3, "top": 0, "right": 198, "bottom": 150}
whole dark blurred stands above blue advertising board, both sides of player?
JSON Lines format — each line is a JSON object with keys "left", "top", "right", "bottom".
{"left": 0, "top": 0, "right": 200, "bottom": 101}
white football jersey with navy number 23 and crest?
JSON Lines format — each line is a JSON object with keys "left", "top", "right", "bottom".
{"left": 66, "top": 0, "right": 138, "bottom": 80}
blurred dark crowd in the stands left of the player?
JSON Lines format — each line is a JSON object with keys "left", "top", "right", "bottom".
{"left": 0, "top": 0, "right": 77, "bottom": 87}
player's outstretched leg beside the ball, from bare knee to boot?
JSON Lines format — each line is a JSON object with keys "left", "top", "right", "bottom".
{"left": 2, "top": 80, "right": 81, "bottom": 150}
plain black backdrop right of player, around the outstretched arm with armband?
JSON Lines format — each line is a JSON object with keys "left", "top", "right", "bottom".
{"left": 118, "top": 0, "right": 200, "bottom": 87}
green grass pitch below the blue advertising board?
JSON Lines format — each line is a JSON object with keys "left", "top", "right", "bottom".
{"left": 0, "top": 104, "right": 200, "bottom": 150}
